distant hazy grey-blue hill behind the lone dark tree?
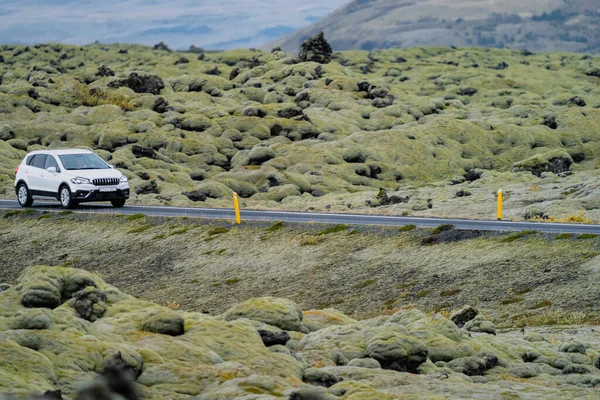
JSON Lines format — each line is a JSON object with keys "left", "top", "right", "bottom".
{"left": 266, "top": 0, "right": 600, "bottom": 53}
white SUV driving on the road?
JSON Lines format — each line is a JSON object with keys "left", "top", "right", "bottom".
{"left": 15, "top": 149, "right": 129, "bottom": 208}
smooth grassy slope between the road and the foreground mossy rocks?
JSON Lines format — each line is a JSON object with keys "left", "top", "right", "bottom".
{"left": 0, "top": 212, "right": 600, "bottom": 325}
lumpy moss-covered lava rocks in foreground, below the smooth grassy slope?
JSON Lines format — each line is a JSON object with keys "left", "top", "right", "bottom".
{"left": 0, "top": 220, "right": 600, "bottom": 400}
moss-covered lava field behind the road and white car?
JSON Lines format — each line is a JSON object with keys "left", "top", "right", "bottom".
{"left": 0, "top": 44, "right": 600, "bottom": 222}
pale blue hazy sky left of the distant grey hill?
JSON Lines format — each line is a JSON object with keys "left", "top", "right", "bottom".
{"left": 0, "top": 0, "right": 347, "bottom": 49}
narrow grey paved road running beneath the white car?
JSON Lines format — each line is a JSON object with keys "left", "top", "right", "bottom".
{"left": 0, "top": 200, "right": 600, "bottom": 235}
